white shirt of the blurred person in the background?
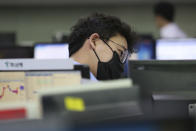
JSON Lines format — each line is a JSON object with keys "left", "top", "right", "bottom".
{"left": 160, "top": 23, "right": 187, "bottom": 38}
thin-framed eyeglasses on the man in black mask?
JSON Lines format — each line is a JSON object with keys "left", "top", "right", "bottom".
{"left": 103, "top": 40, "right": 130, "bottom": 64}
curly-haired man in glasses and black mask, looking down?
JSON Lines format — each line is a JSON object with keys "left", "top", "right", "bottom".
{"left": 69, "top": 14, "right": 135, "bottom": 80}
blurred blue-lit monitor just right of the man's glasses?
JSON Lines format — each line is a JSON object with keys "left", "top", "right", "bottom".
{"left": 131, "top": 35, "right": 155, "bottom": 60}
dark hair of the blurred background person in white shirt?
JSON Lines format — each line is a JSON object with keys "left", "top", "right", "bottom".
{"left": 154, "top": 2, "right": 175, "bottom": 22}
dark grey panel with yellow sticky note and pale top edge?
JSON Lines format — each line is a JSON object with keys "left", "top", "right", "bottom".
{"left": 39, "top": 79, "right": 142, "bottom": 124}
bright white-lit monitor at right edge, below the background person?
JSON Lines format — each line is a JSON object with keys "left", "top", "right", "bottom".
{"left": 156, "top": 39, "right": 196, "bottom": 60}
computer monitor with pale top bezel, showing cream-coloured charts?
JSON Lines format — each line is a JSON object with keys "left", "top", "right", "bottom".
{"left": 0, "top": 59, "right": 89, "bottom": 119}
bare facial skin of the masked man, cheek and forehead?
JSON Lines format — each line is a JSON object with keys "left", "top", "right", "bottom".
{"left": 95, "top": 34, "right": 128, "bottom": 62}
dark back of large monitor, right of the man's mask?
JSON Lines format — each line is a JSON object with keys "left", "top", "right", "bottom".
{"left": 129, "top": 60, "right": 196, "bottom": 93}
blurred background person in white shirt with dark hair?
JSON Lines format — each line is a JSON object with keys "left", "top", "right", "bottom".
{"left": 154, "top": 2, "right": 186, "bottom": 38}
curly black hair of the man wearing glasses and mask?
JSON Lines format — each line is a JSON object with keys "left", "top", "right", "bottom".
{"left": 68, "top": 13, "right": 136, "bottom": 56}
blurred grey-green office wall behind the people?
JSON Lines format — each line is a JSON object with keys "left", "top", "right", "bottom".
{"left": 0, "top": 4, "right": 196, "bottom": 45}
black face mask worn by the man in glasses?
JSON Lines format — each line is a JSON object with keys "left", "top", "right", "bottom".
{"left": 94, "top": 51, "right": 124, "bottom": 80}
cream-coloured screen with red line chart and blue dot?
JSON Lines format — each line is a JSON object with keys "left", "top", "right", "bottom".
{"left": 0, "top": 71, "right": 81, "bottom": 103}
